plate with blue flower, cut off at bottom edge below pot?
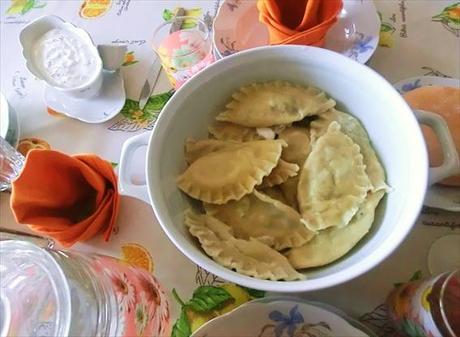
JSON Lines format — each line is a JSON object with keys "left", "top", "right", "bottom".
{"left": 192, "top": 297, "right": 368, "bottom": 337}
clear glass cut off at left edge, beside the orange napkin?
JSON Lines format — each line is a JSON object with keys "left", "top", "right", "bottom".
{"left": 0, "top": 137, "right": 25, "bottom": 192}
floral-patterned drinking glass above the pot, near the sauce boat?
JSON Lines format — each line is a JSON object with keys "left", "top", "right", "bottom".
{"left": 152, "top": 16, "right": 214, "bottom": 89}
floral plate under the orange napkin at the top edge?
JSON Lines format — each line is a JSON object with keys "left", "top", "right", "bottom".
{"left": 213, "top": 0, "right": 380, "bottom": 63}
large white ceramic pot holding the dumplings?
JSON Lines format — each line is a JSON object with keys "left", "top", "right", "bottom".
{"left": 120, "top": 46, "right": 456, "bottom": 292}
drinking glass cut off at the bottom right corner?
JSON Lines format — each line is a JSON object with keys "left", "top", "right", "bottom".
{"left": 387, "top": 270, "right": 460, "bottom": 337}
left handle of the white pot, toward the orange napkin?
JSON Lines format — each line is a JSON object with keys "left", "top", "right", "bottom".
{"left": 118, "top": 132, "right": 150, "bottom": 204}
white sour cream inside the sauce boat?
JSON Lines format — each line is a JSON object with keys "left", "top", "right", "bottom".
{"left": 33, "top": 28, "right": 100, "bottom": 88}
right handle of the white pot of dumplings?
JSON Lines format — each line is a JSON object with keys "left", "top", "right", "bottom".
{"left": 414, "top": 110, "right": 460, "bottom": 186}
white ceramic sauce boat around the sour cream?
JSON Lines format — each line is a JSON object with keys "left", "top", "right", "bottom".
{"left": 19, "top": 15, "right": 103, "bottom": 98}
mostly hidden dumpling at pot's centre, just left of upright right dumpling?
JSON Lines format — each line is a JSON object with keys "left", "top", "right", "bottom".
{"left": 279, "top": 127, "right": 310, "bottom": 167}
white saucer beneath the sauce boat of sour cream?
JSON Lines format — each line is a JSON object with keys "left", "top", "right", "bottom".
{"left": 45, "top": 71, "right": 126, "bottom": 123}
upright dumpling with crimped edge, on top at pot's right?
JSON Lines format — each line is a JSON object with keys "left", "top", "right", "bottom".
{"left": 297, "top": 122, "right": 372, "bottom": 231}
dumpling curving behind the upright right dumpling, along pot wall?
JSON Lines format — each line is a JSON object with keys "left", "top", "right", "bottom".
{"left": 310, "top": 109, "right": 390, "bottom": 192}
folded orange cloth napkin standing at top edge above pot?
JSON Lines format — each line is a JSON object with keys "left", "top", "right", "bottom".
{"left": 257, "top": 0, "right": 342, "bottom": 47}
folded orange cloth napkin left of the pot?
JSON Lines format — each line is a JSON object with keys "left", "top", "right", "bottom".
{"left": 11, "top": 150, "right": 120, "bottom": 247}
